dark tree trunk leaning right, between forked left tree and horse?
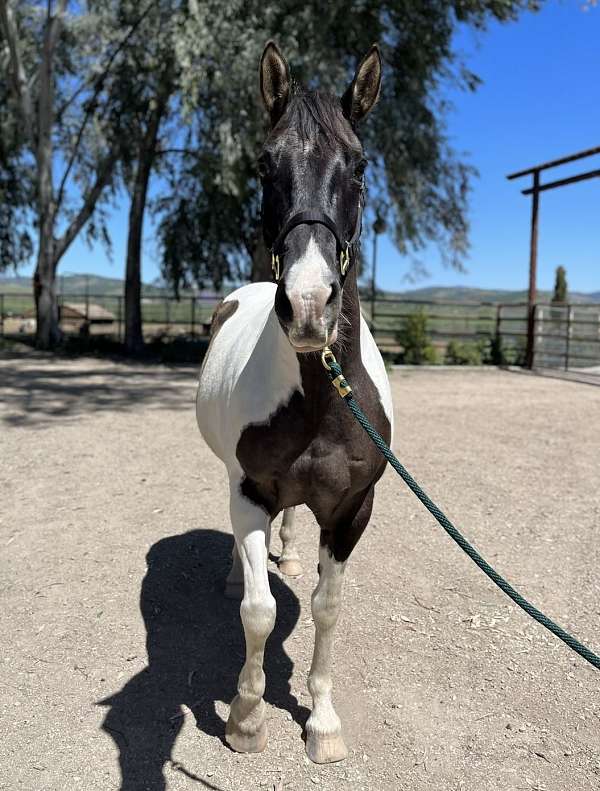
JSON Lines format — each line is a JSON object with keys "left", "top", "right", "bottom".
{"left": 125, "top": 91, "right": 170, "bottom": 354}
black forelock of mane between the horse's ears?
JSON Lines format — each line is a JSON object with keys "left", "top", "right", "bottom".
{"left": 277, "top": 85, "right": 360, "bottom": 151}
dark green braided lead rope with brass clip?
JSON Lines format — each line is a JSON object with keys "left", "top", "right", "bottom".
{"left": 322, "top": 348, "right": 600, "bottom": 670}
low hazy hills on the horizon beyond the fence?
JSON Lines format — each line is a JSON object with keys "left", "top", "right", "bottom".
{"left": 0, "top": 274, "right": 600, "bottom": 303}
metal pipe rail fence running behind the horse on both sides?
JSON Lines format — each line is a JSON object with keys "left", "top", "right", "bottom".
{"left": 0, "top": 293, "right": 600, "bottom": 376}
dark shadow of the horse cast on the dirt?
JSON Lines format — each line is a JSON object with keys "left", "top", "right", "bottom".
{"left": 98, "top": 530, "right": 309, "bottom": 791}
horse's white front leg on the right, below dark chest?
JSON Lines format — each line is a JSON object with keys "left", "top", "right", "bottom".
{"left": 306, "top": 547, "right": 348, "bottom": 764}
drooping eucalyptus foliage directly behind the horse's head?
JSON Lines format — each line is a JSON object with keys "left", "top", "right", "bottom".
{"left": 158, "top": 0, "right": 539, "bottom": 285}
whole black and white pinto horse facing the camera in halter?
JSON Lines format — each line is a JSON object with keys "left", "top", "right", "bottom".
{"left": 197, "top": 42, "right": 392, "bottom": 763}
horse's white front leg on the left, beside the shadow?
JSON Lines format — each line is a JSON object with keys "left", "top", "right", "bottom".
{"left": 225, "top": 481, "right": 275, "bottom": 753}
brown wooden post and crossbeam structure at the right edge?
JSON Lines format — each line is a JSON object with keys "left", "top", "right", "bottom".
{"left": 506, "top": 146, "right": 600, "bottom": 368}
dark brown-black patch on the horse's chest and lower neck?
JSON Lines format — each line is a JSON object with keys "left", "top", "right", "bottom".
{"left": 236, "top": 272, "right": 391, "bottom": 562}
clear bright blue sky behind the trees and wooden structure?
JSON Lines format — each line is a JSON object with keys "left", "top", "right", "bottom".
{"left": 34, "top": 0, "right": 600, "bottom": 291}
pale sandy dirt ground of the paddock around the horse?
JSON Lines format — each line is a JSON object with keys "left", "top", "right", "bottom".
{"left": 0, "top": 352, "right": 600, "bottom": 791}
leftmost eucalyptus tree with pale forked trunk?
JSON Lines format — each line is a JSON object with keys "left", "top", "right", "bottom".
{"left": 0, "top": 0, "right": 152, "bottom": 348}
